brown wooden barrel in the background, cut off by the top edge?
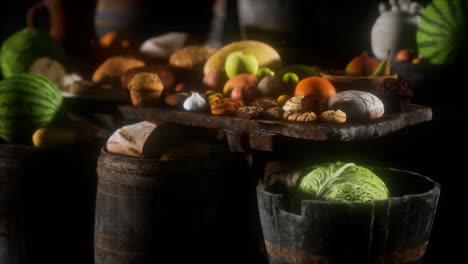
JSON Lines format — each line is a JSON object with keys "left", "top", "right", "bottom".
{"left": 94, "top": 0, "right": 143, "bottom": 38}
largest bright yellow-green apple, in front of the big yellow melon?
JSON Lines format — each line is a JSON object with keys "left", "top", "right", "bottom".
{"left": 224, "top": 51, "right": 259, "bottom": 78}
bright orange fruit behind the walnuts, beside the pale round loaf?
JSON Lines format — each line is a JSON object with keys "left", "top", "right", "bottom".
{"left": 294, "top": 76, "right": 336, "bottom": 99}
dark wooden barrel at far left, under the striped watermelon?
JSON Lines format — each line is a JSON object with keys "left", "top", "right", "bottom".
{"left": 0, "top": 145, "right": 99, "bottom": 264}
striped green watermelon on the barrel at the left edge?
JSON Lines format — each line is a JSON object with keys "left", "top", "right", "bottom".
{"left": 0, "top": 73, "right": 63, "bottom": 144}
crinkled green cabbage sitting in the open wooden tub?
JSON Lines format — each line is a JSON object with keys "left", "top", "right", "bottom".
{"left": 290, "top": 161, "right": 389, "bottom": 211}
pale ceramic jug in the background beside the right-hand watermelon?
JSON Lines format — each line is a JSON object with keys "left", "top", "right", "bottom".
{"left": 371, "top": 0, "right": 424, "bottom": 59}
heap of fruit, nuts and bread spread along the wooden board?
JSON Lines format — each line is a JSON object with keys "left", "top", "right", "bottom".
{"left": 122, "top": 40, "right": 410, "bottom": 123}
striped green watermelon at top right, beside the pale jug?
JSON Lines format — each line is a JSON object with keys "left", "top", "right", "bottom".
{"left": 416, "top": 0, "right": 468, "bottom": 64}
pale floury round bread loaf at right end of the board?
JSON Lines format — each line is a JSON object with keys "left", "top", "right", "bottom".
{"left": 328, "top": 90, "right": 384, "bottom": 120}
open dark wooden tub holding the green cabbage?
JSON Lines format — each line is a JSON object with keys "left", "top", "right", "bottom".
{"left": 257, "top": 169, "right": 440, "bottom": 264}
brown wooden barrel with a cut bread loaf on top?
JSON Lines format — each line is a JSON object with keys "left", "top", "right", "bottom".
{"left": 95, "top": 146, "right": 255, "bottom": 264}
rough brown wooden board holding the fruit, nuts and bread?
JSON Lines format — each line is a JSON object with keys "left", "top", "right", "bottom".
{"left": 119, "top": 104, "right": 432, "bottom": 151}
